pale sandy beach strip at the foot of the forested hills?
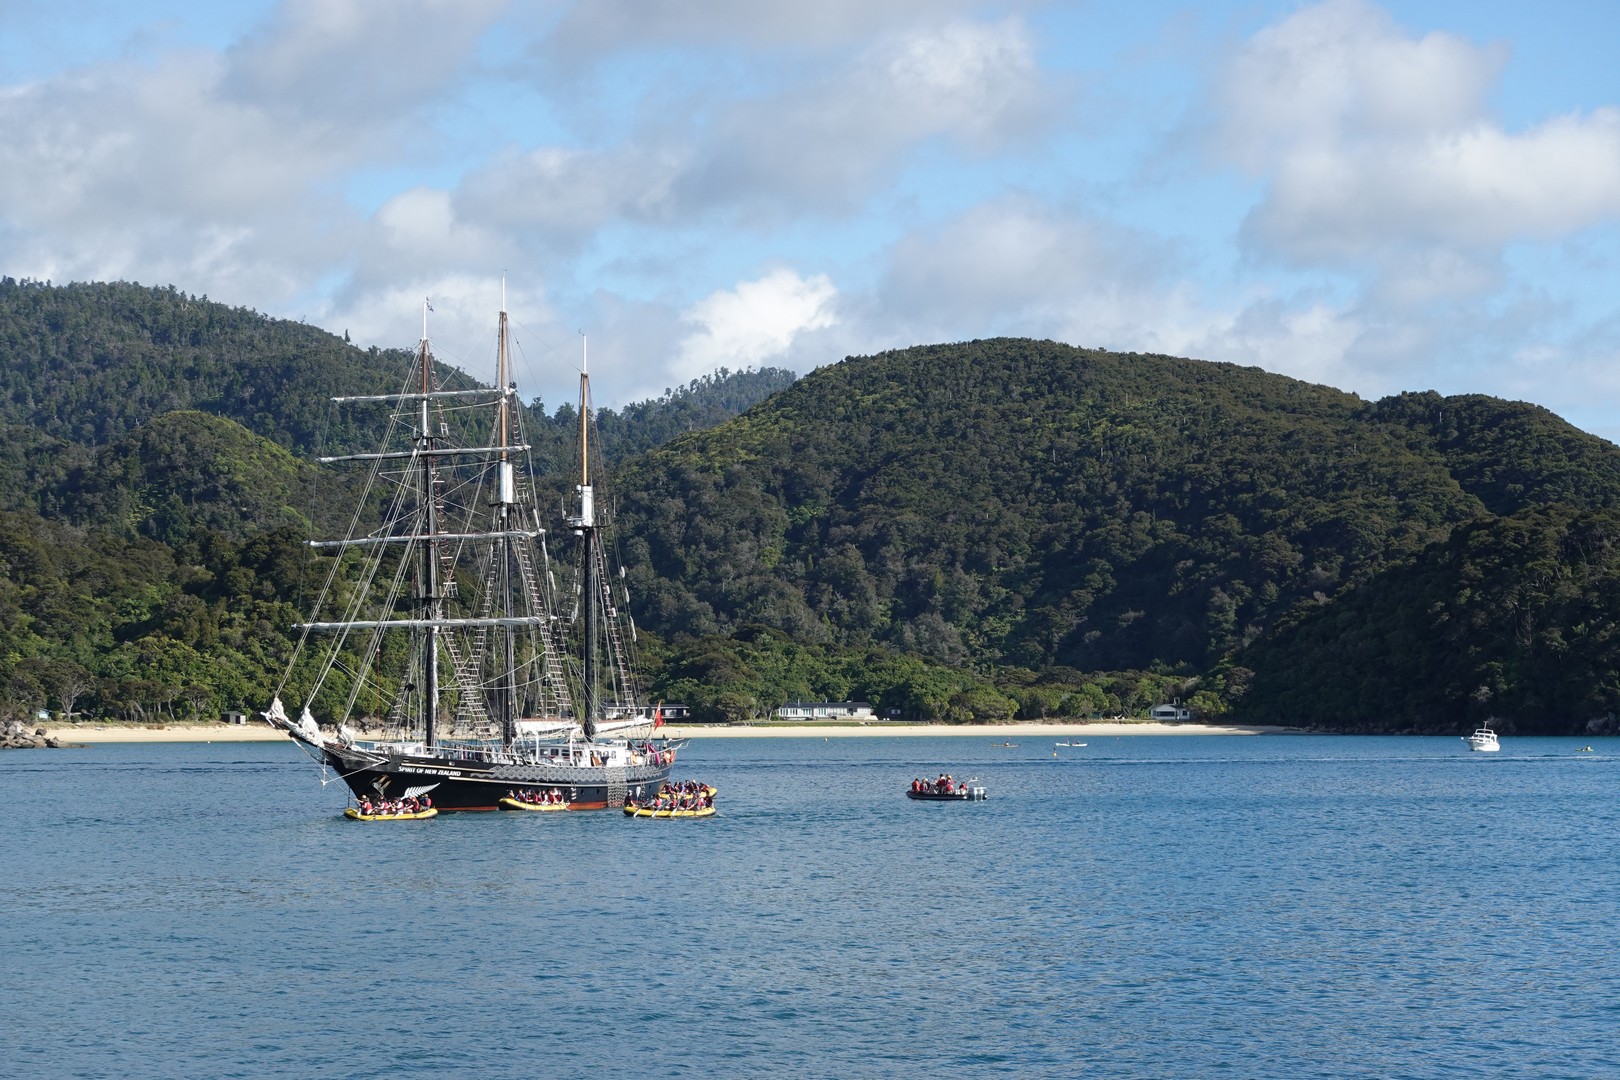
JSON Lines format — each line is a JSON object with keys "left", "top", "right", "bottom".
{"left": 45, "top": 721, "right": 1299, "bottom": 745}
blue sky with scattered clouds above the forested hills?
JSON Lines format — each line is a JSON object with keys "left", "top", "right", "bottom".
{"left": 0, "top": 0, "right": 1620, "bottom": 439}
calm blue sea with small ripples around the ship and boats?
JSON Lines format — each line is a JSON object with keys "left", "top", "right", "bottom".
{"left": 0, "top": 735, "right": 1620, "bottom": 1080}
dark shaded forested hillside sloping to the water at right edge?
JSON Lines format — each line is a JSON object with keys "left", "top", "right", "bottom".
{"left": 1239, "top": 505, "right": 1620, "bottom": 735}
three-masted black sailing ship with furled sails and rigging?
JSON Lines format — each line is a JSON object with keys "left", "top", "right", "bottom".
{"left": 262, "top": 303, "right": 682, "bottom": 810}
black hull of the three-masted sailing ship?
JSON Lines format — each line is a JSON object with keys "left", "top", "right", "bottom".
{"left": 322, "top": 746, "right": 674, "bottom": 810}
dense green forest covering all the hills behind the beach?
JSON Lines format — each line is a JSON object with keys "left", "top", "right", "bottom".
{"left": 0, "top": 279, "right": 1620, "bottom": 730}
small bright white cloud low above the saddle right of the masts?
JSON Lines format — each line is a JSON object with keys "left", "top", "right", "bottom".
{"left": 674, "top": 269, "right": 838, "bottom": 379}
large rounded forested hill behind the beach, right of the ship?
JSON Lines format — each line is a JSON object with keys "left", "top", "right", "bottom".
{"left": 622, "top": 340, "right": 1620, "bottom": 709}
